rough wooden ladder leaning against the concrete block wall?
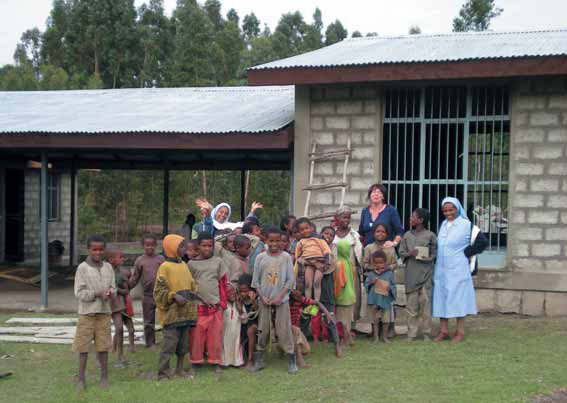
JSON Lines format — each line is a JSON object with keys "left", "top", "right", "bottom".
{"left": 302, "top": 137, "right": 352, "bottom": 220}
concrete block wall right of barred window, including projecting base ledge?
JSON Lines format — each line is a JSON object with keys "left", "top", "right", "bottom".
{"left": 475, "top": 77, "right": 567, "bottom": 316}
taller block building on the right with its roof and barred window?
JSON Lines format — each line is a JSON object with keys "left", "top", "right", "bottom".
{"left": 253, "top": 31, "right": 567, "bottom": 316}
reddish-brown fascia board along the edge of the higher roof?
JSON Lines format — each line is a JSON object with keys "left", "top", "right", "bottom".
{"left": 248, "top": 56, "right": 567, "bottom": 85}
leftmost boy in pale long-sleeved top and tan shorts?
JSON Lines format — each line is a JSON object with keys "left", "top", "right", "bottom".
{"left": 73, "top": 236, "right": 116, "bottom": 391}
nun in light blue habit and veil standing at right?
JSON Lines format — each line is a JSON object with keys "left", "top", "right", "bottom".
{"left": 432, "top": 197, "right": 484, "bottom": 343}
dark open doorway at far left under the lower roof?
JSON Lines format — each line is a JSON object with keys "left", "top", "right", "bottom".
{"left": 5, "top": 169, "right": 24, "bottom": 261}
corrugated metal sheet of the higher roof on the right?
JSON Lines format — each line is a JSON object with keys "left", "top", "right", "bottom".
{"left": 251, "top": 29, "right": 567, "bottom": 70}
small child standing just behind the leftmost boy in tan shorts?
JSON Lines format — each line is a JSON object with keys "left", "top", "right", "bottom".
{"left": 106, "top": 247, "right": 134, "bottom": 367}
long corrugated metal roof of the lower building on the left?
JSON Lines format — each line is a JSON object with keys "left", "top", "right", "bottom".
{"left": 0, "top": 86, "right": 295, "bottom": 134}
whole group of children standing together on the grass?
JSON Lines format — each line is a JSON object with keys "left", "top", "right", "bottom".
{"left": 73, "top": 205, "right": 436, "bottom": 389}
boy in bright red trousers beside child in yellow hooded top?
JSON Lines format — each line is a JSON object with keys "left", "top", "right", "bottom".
{"left": 189, "top": 232, "right": 228, "bottom": 372}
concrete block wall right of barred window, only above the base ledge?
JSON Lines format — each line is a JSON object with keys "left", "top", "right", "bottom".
{"left": 508, "top": 78, "right": 567, "bottom": 273}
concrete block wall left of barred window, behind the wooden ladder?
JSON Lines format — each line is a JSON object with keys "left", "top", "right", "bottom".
{"left": 294, "top": 85, "right": 382, "bottom": 227}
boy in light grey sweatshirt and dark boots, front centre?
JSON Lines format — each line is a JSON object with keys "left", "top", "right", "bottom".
{"left": 252, "top": 229, "right": 298, "bottom": 374}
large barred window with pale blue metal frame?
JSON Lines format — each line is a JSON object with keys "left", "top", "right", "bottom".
{"left": 382, "top": 86, "right": 510, "bottom": 251}
